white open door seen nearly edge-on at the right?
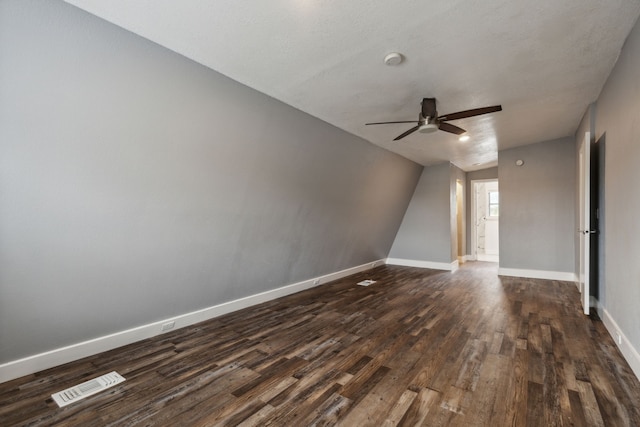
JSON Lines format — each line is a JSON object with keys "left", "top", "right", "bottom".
{"left": 578, "top": 132, "right": 592, "bottom": 315}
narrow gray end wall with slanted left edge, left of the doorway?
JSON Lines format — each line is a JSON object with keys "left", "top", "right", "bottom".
{"left": 389, "top": 163, "right": 451, "bottom": 263}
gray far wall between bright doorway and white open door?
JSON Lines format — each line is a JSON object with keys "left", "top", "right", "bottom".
{"left": 498, "top": 137, "right": 576, "bottom": 272}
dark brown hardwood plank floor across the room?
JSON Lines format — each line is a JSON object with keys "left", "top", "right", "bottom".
{"left": 0, "top": 263, "right": 640, "bottom": 426}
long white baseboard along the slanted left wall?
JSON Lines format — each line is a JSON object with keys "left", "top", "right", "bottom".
{"left": 0, "top": 259, "right": 386, "bottom": 383}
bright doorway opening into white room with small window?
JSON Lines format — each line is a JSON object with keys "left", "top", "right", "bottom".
{"left": 471, "top": 179, "right": 500, "bottom": 262}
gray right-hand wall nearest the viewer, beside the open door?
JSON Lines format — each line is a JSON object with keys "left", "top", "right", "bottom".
{"left": 595, "top": 14, "right": 640, "bottom": 351}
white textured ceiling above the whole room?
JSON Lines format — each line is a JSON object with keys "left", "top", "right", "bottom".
{"left": 67, "top": 0, "right": 640, "bottom": 171}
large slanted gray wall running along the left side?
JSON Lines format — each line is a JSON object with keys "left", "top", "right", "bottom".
{"left": 0, "top": 0, "right": 424, "bottom": 363}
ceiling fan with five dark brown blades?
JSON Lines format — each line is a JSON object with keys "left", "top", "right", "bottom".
{"left": 365, "top": 98, "right": 502, "bottom": 141}
